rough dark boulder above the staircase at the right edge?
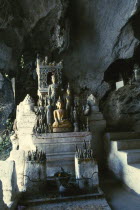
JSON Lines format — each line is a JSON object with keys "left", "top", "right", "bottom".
{"left": 101, "top": 85, "right": 140, "bottom": 131}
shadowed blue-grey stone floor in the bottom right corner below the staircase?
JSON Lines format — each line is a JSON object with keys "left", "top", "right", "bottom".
{"left": 100, "top": 172, "right": 140, "bottom": 210}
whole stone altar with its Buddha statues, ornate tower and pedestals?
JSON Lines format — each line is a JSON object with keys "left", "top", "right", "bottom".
{"left": 5, "top": 58, "right": 99, "bottom": 204}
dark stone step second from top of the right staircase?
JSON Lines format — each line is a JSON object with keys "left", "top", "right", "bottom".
{"left": 117, "top": 139, "right": 140, "bottom": 150}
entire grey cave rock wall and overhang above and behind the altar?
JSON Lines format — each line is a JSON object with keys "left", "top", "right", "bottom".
{"left": 0, "top": 0, "right": 140, "bottom": 139}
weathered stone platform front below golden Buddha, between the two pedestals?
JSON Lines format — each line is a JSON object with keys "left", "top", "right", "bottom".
{"left": 33, "top": 132, "right": 92, "bottom": 176}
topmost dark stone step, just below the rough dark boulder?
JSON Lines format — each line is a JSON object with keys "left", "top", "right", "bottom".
{"left": 109, "top": 132, "right": 140, "bottom": 141}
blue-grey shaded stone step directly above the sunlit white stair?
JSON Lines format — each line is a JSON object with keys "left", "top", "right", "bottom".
{"left": 122, "top": 149, "right": 140, "bottom": 164}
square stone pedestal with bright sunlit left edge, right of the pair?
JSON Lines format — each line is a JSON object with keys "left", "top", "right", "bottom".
{"left": 75, "top": 157, "right": 99, "bottom": 190}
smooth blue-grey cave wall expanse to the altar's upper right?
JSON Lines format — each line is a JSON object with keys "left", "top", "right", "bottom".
{"left": 64, "top": 0, "right": 139, "bottom": 98}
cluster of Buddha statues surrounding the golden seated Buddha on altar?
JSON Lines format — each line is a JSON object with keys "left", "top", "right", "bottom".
{"left": 34, "top": 75, "right": 89, "bottom": 134}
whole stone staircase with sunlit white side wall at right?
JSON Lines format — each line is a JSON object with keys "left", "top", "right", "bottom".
{"left": 105, "top": 132, "right": 140, "bottom": 194}
